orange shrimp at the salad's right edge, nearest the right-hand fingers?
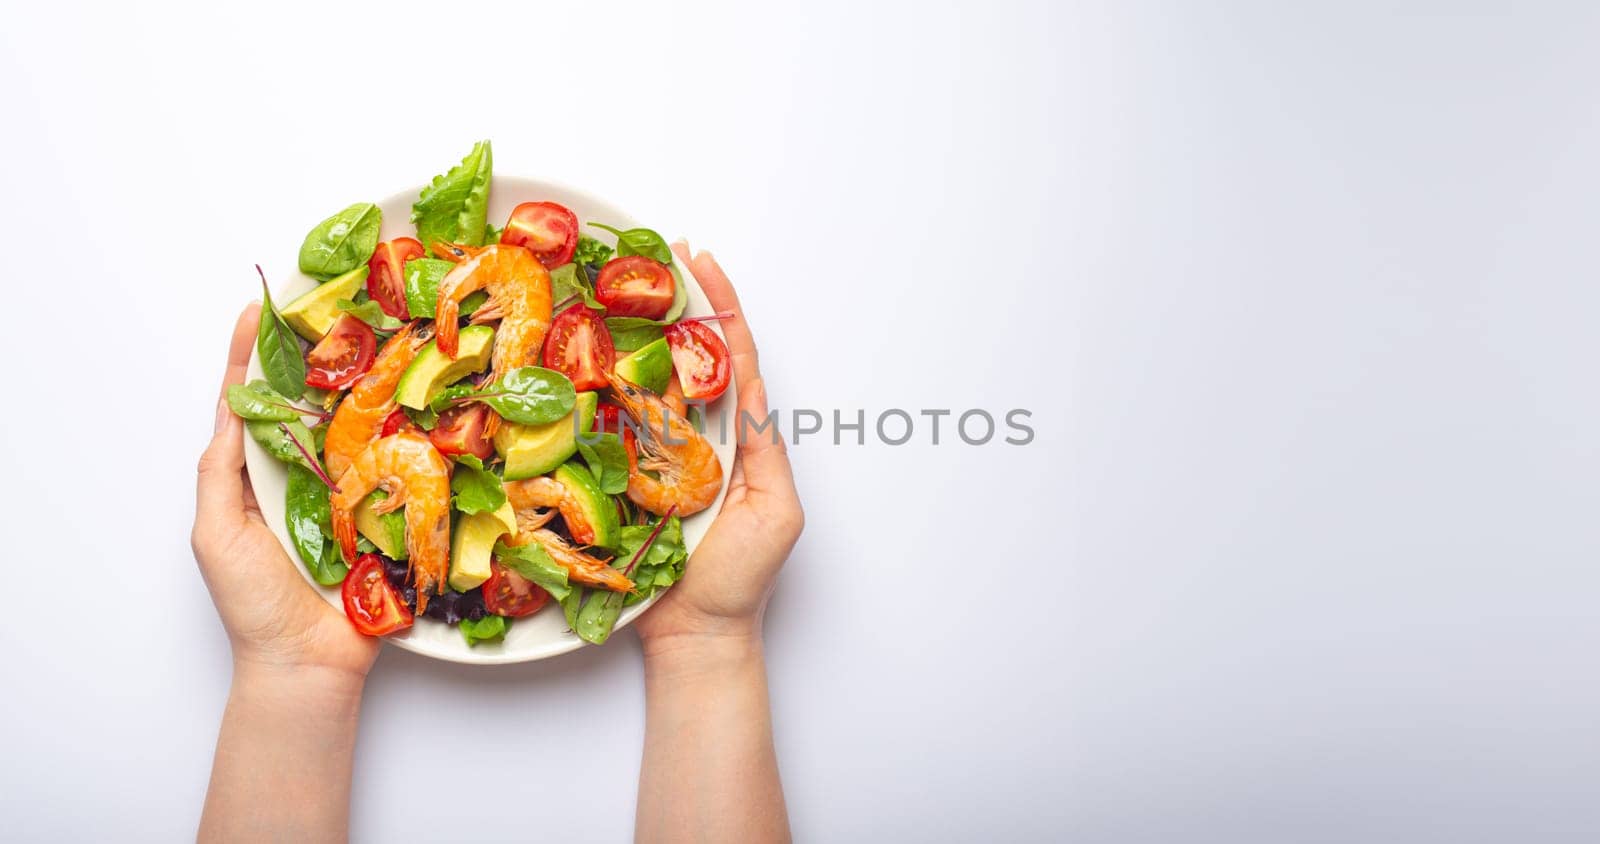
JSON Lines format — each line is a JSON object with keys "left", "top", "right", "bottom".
{"left": 611, "top": 376, "right": 722, "bottom": 516}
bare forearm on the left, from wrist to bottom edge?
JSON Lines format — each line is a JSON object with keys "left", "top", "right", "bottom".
{"left": 198, "top": 665, "right": 362, "bottom": 841}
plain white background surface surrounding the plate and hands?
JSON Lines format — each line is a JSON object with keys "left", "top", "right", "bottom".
{"left": 0, "top": 2, "right": 1600, "bottom": 842}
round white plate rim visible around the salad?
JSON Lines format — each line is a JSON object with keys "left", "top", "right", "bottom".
{"left": 245, "top": 176, "right": 738, "bottom": 665}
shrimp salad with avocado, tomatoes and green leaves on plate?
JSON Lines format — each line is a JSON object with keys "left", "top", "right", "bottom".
{"left": 227, "top": 141, "right": 730, "bottom": 646}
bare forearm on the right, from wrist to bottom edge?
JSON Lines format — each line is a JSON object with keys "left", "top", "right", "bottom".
{"left": 634, "top": 636, "right": 789, "bottom": 842}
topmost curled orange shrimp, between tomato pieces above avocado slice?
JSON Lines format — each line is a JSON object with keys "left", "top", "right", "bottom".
{"left": 434, "top": 243, "right": 552, "bottom": 379}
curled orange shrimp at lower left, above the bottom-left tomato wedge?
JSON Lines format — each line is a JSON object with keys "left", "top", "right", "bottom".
{"left": 331, "top": 432, "right": 450, "bottom": 612}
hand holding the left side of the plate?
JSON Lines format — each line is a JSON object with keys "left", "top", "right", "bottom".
{"left": 190, "top": 305, "right": 379, "bottom": 679}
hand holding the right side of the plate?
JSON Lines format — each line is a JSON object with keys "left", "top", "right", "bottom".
{"left": 634, "top": 241, "right": 805, "bottom": 654}
